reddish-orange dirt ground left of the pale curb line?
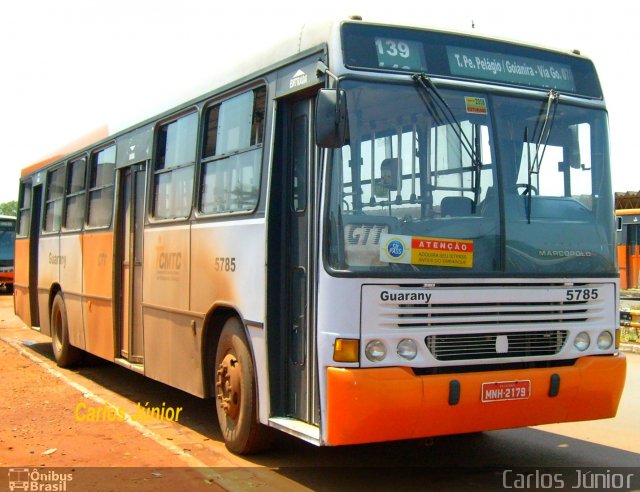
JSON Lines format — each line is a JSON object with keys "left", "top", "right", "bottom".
{"left": 0, "top": 342, "right": 224, "bottom": 491}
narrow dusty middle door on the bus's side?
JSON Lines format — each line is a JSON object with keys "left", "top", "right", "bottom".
{"left": 116, "top": 163, "right": 146, "bottom": 364}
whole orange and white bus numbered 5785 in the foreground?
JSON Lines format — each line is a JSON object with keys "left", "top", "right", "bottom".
{"left": 15, "top": 19, "right": 626, "bottom": 453}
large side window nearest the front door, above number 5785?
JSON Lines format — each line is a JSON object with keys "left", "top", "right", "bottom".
{"left": 199, "top": 87, "right": 266, "bottom": 214}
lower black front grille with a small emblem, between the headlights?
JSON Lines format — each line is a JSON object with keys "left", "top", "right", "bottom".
{"left": 425, "top": 330, "right": 568, "bottom": 361}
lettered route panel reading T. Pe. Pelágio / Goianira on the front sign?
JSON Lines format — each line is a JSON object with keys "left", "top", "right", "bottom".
{"left": 447, "top": 46, "right": 576, "bottom": 92}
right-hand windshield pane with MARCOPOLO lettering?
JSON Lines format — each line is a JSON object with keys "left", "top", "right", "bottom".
{"left": 493, "top": 95, "right": 615, "bottom": 275}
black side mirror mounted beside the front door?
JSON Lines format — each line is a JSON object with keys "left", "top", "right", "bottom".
{"left": 315, "top": 89, "right": 348, "bottom": 149}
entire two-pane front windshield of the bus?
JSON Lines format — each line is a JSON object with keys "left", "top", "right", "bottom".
{"left": 327, "top": 80, "right": 615, "bottom": 276}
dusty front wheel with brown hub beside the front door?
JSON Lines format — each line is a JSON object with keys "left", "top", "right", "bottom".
{"left": 214, "top": 318, "right": 269, "bottom": 454}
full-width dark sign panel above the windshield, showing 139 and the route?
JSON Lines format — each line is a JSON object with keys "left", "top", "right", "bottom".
{"left": 342, "top": 22, "right": 602, "bottom": 98}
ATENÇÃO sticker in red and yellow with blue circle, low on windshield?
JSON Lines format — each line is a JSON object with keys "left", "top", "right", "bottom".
{"left": 380, "top": 234, "right": 473, "bottom": 268}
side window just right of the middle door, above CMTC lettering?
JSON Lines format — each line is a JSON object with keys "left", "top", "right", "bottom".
{"left": 153, "top": 113, "right": 198, "bottom": 219}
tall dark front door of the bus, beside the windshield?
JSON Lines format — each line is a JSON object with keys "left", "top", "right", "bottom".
{"left": 267, "top": 98, "right": 319, "bottom": 425}
